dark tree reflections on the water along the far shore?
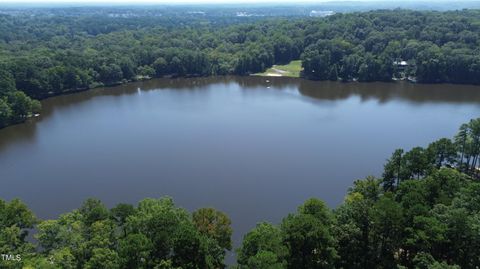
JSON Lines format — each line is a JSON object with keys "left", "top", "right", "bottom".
{"left": 0, "top": 76, "right": 480, "bottom": 151}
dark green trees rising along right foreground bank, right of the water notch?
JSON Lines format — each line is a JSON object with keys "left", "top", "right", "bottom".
{"left": 238, "top": 119, "right": 480, "bottom": 269}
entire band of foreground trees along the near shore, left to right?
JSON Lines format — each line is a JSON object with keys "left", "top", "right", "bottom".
{"left": 0, "top": 119, "right": 480, "bottom": 269}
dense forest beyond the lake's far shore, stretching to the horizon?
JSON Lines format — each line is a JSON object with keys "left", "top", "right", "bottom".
{"left": 0, "top": 9, "right": 480, "bottom": 128}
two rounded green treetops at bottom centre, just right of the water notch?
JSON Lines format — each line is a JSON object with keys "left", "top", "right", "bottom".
{"left": 237, "top": 199, "right": 338, "bottom": 269}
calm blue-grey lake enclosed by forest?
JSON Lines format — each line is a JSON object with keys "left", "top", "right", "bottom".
{"left": 0, "top": 74, "right": 480, "bottom": 248}
